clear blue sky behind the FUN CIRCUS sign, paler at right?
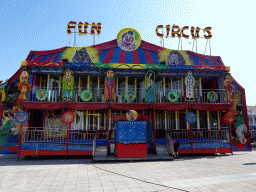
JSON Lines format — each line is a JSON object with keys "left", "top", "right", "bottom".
{"left": 0, "top": 0, "right": 256, "bottom": 105}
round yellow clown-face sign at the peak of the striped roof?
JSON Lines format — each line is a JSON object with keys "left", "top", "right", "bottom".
{"left": 117, "top": 28, "right": 141, "bottom": 51}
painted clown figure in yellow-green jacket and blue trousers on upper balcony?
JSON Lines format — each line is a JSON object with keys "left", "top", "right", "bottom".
{"left": 62, "top": 69, "right": 74, "bottom": 101}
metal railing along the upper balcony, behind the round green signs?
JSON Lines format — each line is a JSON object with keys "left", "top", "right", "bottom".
{"left": 27, "top": 87, "right": 228, "bottom": 103}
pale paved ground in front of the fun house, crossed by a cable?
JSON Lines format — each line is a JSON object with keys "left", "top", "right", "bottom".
{"left": 0, "top": 147, "right": 256, "bottom": 192}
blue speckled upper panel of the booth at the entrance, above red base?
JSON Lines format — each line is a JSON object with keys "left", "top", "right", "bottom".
{"left": 116, "top": 121, "right": 147, "bottom": 144}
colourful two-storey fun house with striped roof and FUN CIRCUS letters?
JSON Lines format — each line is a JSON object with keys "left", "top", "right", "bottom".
{"left": 0, "top": 22, "right": 251, "bottom": 159}
